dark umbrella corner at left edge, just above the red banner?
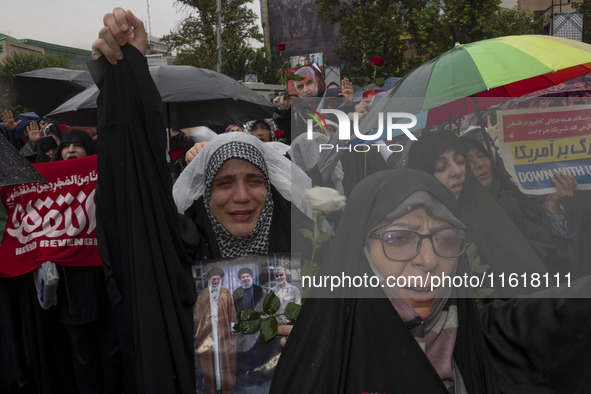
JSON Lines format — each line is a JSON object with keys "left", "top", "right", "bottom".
{"left": 0, "top": 137, "right": 47, "bottom": 187}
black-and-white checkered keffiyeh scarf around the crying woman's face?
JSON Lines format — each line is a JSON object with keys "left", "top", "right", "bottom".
{"left": 203, "top": 142, "right": 273, "bottom": 257}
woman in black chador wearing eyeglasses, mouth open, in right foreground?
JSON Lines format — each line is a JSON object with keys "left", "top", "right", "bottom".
{"left": 271, "top": 169, "right": 591, "bottom": 394}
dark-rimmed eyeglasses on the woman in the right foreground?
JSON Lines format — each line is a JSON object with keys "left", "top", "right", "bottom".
{"left": 370, "top": 227, "right": 466, "bottom": 261}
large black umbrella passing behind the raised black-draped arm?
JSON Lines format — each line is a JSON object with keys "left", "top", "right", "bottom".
{"left": 49, "top": 66, "right": 275, "bottom": 128}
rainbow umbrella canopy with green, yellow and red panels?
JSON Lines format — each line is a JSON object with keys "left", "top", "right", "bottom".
{"left": 366, "top": 35, "right": 591, "bottom": 129}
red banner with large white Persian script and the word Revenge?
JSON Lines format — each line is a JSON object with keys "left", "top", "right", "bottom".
{"left": 0, "top": 155, "right": 102, "bottom": 277}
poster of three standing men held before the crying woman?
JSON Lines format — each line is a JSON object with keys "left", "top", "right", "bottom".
{"left": 193, "top": 254, "right": 302, "bottom": 393}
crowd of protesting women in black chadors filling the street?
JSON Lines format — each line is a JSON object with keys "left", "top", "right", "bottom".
{"left": 0, "top": 8, "right": 591, "bottom": 393}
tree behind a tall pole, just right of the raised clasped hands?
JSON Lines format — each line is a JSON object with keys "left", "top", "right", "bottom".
{"left": 163, "top": 0, "right": 262, "bottom": 71}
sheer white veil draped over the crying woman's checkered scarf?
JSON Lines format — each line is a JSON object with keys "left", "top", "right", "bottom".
{"left": 172, "top": 133, "right": 313, "bottom": 218}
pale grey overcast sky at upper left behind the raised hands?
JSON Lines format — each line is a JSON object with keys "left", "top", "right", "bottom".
{"left": 0, "top": 0, "right": 260, "bottom": 50}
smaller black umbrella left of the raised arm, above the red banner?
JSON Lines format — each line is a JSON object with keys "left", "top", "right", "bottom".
{"left": 11, "top": 67, "right": 94, "bottom": 116}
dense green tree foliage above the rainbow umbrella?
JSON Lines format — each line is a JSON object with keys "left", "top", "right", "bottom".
{"left": 317, "top": 0, "right": 543, "bottom": 81}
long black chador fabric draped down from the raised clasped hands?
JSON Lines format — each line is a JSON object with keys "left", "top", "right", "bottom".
{"left": 88, "top": 45, "right": 195, "bottom": 394}
